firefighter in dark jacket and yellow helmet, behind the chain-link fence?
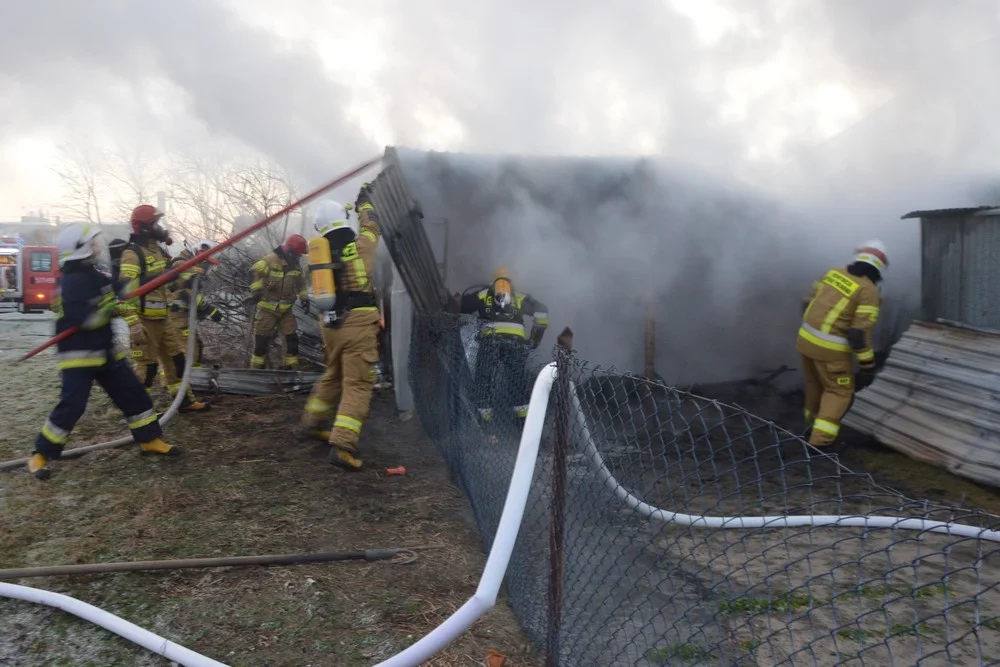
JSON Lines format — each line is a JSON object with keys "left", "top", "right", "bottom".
{"left": 460, "top": 269, "right": 549, "bottom": 422}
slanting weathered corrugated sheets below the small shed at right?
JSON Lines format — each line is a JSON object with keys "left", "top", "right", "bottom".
{"left": 844, "top": 322, "right": 1000, "bottom": 486}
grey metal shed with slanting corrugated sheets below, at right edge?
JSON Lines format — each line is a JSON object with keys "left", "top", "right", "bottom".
{"left": 844, "top": 206, "right": 1000, "bottom": 486}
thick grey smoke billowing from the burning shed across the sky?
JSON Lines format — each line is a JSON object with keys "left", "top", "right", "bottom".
{"left": 0, "top": 0, "right": 1000, "bottom": 382}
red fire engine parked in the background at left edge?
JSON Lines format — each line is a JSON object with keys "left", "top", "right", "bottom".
{"left": 0, "top": 235, "right": 59, "bottom": 313}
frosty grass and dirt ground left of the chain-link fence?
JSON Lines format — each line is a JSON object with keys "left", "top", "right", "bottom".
{"left": 0, "top": 314, "right": 540, "bottom": 667}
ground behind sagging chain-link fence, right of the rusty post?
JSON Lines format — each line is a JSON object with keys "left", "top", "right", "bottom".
{"left": 595, "top": 378, "right": 1000, "bottom": 665}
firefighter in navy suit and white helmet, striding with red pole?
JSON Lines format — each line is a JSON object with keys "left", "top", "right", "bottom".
{"left": 28, "top": 223, "right": 181, "bottom": 479}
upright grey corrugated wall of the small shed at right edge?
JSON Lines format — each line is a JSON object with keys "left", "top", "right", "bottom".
{"left": 920, "top": 214, "right": 1000, "bottom": 329}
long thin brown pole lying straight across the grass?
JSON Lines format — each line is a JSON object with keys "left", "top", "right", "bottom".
{"left": 0, "top": 545, "right": 440, "bottom": 579}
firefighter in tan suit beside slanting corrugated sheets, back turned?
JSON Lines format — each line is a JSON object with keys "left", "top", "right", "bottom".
{"left": 795, "top": 240, "right": 889, "bottom": 447}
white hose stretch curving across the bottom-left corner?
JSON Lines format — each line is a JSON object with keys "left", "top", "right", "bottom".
{"left": 0, "top": 582, "right": 227, "bottom": 667}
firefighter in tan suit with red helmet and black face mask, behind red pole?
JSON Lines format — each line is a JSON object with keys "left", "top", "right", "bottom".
{"left": 119, "top": 204, "right": 209, "bottom": 412}
